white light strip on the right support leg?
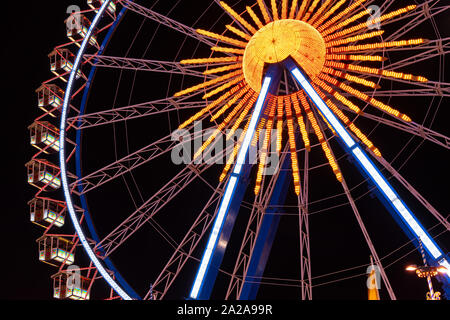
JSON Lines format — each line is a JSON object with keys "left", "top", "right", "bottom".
{"left": 290, "top": 67, "right": 444, "bottom": 264}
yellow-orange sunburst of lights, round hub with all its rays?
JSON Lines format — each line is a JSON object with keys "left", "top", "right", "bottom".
{"left": 175, "top": 0, "right": 428, "bottom": 194}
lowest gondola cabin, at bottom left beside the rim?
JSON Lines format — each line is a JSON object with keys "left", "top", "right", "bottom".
{"left": 52, "top": 270, "right": 92, "bottom": 300}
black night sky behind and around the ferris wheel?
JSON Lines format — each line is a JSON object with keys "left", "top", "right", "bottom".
{"left": 0, "top": 0, "right": 450, "bottom": 300}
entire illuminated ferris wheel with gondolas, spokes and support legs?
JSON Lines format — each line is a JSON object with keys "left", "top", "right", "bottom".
{"left": 26, "top": 0, "right": 450, "bottom": 300}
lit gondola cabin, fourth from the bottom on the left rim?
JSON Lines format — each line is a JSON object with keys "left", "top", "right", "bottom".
{"left": 25, "top": 159, "right": 61, "bottom": 191}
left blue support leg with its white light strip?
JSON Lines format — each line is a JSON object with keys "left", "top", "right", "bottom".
{"left": 189, "top": 65, "right": 280, "bottom": 300}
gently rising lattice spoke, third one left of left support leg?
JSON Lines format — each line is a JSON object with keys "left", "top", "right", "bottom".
{"left": 70, "top": 117, "right": 221, "bottom": 195}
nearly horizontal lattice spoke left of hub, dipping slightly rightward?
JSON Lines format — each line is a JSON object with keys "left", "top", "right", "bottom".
{"left": 84, "top": 55, "right": 217, "bottom": 79}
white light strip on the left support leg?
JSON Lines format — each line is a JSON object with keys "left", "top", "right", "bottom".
{"left": 189, "top": 74, "right": 273, "bottom": 299}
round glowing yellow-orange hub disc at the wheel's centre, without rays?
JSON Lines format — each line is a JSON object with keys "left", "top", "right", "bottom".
{"left": 243, "top": 19, "right": 326, "bottom": 92}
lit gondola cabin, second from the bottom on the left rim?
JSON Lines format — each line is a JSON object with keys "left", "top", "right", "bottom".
{"left": 36, "top": 235, "right": 75, "bottom": 267}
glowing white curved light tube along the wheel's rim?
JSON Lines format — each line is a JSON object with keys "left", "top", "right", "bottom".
{"left": 59, "top": 0, "right": 132, "bottom": 300}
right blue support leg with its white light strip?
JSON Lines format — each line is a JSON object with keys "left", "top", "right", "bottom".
{"left": 285, "top": 59, "right": 450, "bottom": 296}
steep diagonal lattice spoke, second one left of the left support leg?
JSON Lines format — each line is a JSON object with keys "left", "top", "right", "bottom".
{"left": 91, "top": 143, "right": 232, "bottom": 258}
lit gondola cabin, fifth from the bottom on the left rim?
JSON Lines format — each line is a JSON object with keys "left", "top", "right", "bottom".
{"left": 28, "top": 121, "right": 59, "bottom": 154}
